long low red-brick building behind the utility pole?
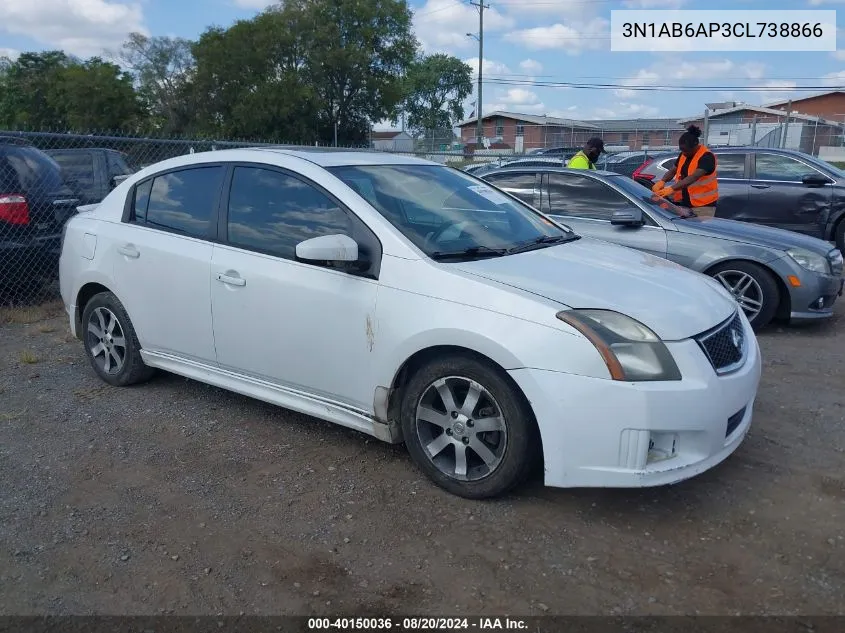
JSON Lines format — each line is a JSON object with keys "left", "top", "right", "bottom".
{"left": 459, "top": 111, "right": 683, "bottom": 153}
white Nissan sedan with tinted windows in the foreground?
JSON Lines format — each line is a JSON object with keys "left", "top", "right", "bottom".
{"left": 61, "top": 149, "right": 761, "bottom": 498}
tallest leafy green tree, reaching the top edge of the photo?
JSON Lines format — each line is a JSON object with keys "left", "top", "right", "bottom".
{"left": 304, "top": 0, "right": 418, "bottom": 143}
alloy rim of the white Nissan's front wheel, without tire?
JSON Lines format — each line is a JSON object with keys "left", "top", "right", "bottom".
{"left": 415, "top": 376, "right": 508, "bottom": 481}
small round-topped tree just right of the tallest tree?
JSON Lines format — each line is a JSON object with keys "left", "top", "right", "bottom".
{"left": 404, "top": 53, "right": 472, "bottom": 138}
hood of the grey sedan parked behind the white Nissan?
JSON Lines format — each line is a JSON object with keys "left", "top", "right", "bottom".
{"left": 673, "top": 212, "right": 833, "bottom": 255}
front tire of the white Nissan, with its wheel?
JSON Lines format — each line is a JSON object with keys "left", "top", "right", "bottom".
{"left": 400, "top": 355, "right": 541, "bottom": 499}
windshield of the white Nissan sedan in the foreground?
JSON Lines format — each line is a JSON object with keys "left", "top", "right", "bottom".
{"left": 329, "top": 165, "right": 578, "bottom": 260}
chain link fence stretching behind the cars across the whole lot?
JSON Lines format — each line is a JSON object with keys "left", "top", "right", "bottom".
{"left": 0, "top": 116, "right": 845, "bottom": 305}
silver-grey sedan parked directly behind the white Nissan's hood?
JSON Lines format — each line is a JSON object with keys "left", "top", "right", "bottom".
{"left": 483, "top": 167, "right": 843, "bottom": 329}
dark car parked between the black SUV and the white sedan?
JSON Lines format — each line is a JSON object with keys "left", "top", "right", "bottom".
{"left": 45, "top": 147, "right": 135, "bottom": 204}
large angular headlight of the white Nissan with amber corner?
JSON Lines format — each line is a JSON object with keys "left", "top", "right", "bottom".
{"left": 557, "top": 310, "right": 681, "bottom": 382}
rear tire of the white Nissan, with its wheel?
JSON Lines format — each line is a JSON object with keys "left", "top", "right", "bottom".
{"left": 82, "top": 292, "right": 155, "bottom": 387}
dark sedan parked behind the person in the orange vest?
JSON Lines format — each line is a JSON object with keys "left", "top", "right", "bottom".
{"left": 634, "top": 147, "right": 845, "bottom": 253}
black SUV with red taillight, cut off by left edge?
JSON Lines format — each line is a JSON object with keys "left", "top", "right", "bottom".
{"left": 0, "top": 137, "right": 79, "bottom": 292}
